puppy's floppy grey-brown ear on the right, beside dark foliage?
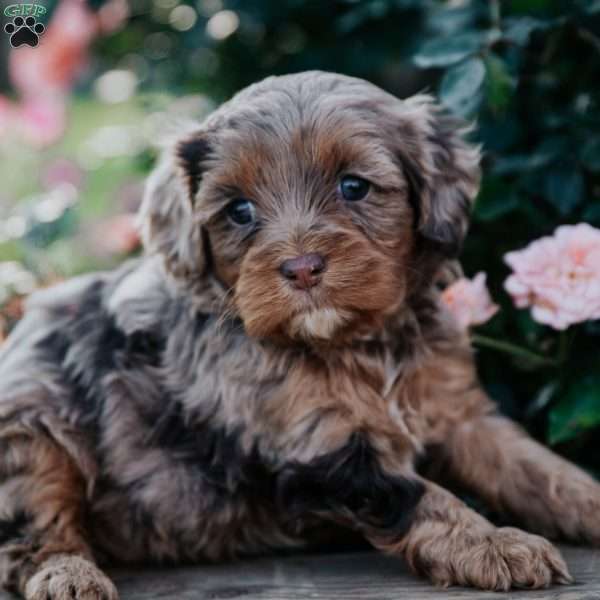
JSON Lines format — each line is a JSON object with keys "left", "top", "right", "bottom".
{"left": 400, "top": 95, "right": 480, "bottom": 257}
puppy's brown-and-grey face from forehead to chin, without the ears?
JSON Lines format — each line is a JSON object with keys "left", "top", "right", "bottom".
{"left": 198, "top": 102, "right": 414, "bottom": 339}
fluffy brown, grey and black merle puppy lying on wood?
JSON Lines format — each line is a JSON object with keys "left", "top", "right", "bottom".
{"left": 0, "top": 72, "right": 600, "bottom": 600}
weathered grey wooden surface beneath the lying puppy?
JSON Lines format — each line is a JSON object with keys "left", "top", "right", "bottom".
{"left": 0, "top": 547, "right": 600, "bottom": 600}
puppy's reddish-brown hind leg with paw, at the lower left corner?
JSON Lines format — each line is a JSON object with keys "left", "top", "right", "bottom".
{"left": 0, "top": 432, "right": 117, "bottom": 600}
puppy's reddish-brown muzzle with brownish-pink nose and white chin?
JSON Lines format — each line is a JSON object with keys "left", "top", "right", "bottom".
{"left": 235, "top": 240, "right": 402, "bottom": 344}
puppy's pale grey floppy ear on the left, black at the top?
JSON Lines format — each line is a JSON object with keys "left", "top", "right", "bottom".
{"left": 138, "top": 132, "right": 211, "bottom": 280}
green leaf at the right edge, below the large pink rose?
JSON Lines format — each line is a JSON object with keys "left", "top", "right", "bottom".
{"left": 548, "top": 375, "right": 600, "bottom": 444}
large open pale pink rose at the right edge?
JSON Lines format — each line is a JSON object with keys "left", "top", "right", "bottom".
{"left": 504, "top": 223, "right": 600, "bottom": 329}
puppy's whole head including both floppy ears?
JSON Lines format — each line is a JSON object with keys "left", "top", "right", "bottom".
{"left": 139, "top": 73, "right": 477, "bottom": 342}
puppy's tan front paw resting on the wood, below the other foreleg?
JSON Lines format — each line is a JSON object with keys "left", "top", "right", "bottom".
{"left": 429, "top": 527, "right": 573, "bottom": 591}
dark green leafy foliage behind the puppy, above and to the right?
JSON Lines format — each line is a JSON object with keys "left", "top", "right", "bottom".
{"left": 1, "top": 0, "right": 600, "bottom": 473}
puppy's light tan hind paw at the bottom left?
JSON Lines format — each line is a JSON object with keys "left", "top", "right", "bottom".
{"left": 25, "top": 554, "right": 119, "bottom": 600}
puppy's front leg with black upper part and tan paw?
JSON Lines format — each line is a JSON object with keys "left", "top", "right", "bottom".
{"left": 278, "top": 432, "right": 570, "bottom": 590}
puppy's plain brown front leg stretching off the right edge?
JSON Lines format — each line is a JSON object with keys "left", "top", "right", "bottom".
{"left": 443, "top": 416, "right": 600, "bottom": 545}
